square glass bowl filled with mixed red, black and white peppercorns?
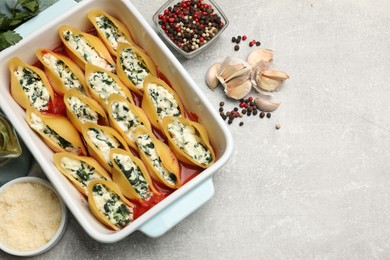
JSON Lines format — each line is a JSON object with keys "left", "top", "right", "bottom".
{"left": 153, "top": 0, "right": 229, "bottom": 59}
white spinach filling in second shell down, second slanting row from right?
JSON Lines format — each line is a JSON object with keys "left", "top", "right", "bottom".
{"left": 88, "top": 71, "right": 127, "bottom": 104}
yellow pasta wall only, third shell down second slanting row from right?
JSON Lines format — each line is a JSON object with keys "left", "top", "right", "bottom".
{"left": 107, "top": 94, "right": 152, "bottom": 150}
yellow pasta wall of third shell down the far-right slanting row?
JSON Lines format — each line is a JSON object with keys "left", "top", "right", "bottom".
{"left": 141, "top": 75, "right": 185, "bottom": 130}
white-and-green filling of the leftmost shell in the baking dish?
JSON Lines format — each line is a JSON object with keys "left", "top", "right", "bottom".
{"left": 14, "top": 66, "right": 50, "bottom": 111}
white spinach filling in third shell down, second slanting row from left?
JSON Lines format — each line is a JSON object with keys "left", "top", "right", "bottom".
{"left": 87, "top": 128, "right": 120, "bottom": 167}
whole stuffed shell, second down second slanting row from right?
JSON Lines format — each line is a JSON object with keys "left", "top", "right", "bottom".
{"left": 85, "top": 64, "right": 134, "bottom": 109}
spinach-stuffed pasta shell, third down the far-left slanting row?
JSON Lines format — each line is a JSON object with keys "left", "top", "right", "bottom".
{"left": 53, "top": 153, "right": 111, "bottom": 196}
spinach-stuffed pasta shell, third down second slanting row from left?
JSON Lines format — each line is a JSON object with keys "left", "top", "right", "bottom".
{"left": 82, "top": 122, "right": 130, "bottom": 172}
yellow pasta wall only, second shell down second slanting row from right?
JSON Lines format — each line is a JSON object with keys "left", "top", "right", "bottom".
{"left": 85, "top": 64, "right": 134, "bottom": 111}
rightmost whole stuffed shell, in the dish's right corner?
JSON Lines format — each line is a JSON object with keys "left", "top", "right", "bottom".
{"left": 162, "top": 116, "right": 215, "bottom": 168}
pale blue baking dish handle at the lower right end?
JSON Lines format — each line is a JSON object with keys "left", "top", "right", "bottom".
{"left": 139, "top": 178, "right": 214, "bottom": 237}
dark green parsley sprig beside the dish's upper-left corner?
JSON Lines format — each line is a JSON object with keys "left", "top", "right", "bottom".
{"left": 0, "top": 0, "right": 47, "bottom": 51}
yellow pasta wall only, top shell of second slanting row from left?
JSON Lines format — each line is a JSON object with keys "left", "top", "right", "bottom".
{"left": 35, "top": 49, "right": 86, "bottom": 96}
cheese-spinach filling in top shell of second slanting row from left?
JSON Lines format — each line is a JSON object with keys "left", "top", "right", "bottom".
{"left": 42, "top": 53, "right": 84, "bottom": 91}
